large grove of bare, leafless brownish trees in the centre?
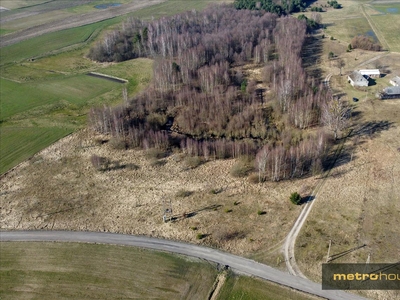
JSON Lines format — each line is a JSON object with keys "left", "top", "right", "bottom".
{"left": 89, "top": 5, "right": 331, "bottom": 180}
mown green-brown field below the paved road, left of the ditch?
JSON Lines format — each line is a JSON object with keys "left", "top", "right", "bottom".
{"left": 0, "top": 242, "right": 217, "bottom": 300}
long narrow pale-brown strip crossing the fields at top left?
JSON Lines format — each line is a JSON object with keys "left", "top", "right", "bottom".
{"left": 0, "top": 0, "right": 166, "bottom": 47}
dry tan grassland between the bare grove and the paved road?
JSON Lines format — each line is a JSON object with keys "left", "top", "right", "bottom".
{"left": 0, "top": 131, "right": 316, "bottom": 261}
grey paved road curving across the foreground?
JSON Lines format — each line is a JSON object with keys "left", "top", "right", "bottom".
{"left": 0, "top": 231, "right": 364, "bottom": 300}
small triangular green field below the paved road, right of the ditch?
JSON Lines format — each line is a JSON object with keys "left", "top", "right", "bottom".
{"left": 218, "top": 275, "right": 318, "bottom": 300}
